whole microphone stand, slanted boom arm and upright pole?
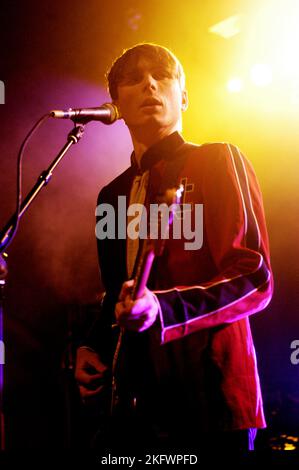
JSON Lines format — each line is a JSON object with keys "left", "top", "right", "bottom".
{"left": 0, "top": 118, "right": 89, "bottom": 450}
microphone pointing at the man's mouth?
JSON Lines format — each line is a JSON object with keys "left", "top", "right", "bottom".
{"left": 50, "top": 103, "right": 121, "bottom": 124}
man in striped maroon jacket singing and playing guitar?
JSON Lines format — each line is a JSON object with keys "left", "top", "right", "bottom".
{"left": 76, "top": 43, "right": 273, "bottom": 451}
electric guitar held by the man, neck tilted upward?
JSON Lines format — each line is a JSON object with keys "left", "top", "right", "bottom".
{"left": 110, "top": 185, "right": 183, "bottom": 416}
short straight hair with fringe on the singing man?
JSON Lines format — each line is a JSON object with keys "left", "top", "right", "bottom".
{"left": 106, "top": 42, "right": 185, "bottom": 100}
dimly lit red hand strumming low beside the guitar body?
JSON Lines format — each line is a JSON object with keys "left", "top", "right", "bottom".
{"left": 75, "top": 347, "right": 108, "bottom": 400}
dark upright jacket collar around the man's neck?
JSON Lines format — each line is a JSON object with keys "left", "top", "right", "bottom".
{"left": 131, "top": 131, "right": 185, "bottom": 173}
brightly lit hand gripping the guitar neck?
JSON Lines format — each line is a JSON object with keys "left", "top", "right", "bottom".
{"left": 115, "top": 279, "right": 159, "bottom": 331}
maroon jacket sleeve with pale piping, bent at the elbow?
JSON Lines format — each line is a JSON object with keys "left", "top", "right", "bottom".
{"left": 154, "top": 144, "right": 273, "bottom": 343}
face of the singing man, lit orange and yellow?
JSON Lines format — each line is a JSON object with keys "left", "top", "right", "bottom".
{"left": 115, "top": 59, "right": 187, "bottom": 132}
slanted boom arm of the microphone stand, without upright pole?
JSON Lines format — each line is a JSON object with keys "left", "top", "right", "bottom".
{"left": 0, "top": 122, "right": 84, "bottom": 253}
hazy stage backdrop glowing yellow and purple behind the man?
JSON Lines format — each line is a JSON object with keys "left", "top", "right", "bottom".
{"left": 0, "top": 0, "right": 299, "bottom": 449}
